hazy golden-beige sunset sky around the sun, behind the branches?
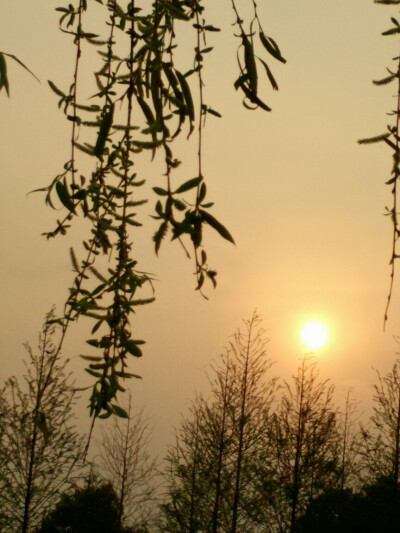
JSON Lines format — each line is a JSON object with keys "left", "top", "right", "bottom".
{"left": 0, "top": 0, "right": 400, "bottom": 448}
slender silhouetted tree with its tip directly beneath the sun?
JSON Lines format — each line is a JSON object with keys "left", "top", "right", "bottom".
{"left": 272, "top": 357, "right": 338, "bottom": 532}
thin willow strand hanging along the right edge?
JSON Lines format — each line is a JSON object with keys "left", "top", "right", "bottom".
{"left": 358, "top": 0, "right": 400, "bottom": 329}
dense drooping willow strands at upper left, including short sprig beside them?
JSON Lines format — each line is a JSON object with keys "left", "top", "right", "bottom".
{"left": 33, "top": 0, "right": 285, "bottom": 417}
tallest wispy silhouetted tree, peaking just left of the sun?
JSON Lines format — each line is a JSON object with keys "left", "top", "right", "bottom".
{"left": 159, "top": 314, "right": 277, "bottom": 532}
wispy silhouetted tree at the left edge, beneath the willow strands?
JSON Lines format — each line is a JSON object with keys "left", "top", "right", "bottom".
{"left": 0, "top": 313, "right": 82, "bottom": 533}
